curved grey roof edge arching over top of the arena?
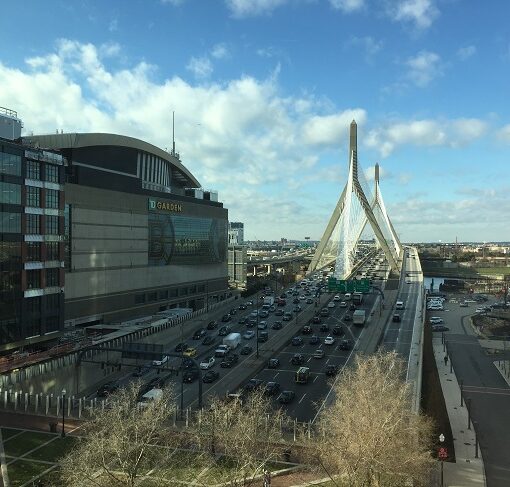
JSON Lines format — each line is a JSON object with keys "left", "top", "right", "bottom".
{"left": 23, "top": 132, "right": 201, "bottom": 188}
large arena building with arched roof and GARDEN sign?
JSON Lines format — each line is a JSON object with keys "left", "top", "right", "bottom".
{"left": 23, "top": 133, "right": 228, "bottom": 325}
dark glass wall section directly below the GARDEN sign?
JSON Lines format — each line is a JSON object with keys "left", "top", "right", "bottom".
{"left": 149, "top": 212, "right": 227, "bottom": 266}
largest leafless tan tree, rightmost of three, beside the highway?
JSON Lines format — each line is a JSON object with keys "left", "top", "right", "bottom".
{"left": 311, "top": 352, "right": 433, "bottom": 486}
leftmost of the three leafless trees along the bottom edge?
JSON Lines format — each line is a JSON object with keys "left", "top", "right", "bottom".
{"left": 61, "top": 383, "right": 173, "bottom": 487}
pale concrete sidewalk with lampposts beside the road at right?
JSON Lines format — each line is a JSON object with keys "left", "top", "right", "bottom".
{"left": 432, "top": 335, "right": 486, "bottom": 487}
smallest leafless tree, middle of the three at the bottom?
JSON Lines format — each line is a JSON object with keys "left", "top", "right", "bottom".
{"left": 189, "top": 391, "right": 287, "bottom": 486}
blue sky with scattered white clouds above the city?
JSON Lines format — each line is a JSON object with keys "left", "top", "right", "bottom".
{"left": 0, "top": 0, "right": 510, "bottom": 242}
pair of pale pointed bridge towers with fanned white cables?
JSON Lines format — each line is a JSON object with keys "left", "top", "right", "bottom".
{"left": 308, "top": 120, "right": 402, "bottom": 279}
